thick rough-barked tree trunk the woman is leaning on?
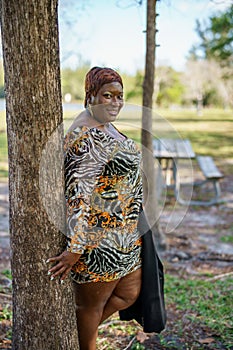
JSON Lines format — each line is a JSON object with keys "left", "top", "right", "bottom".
{"left": 1, "top": 0, "right": 78, "bottom": 350}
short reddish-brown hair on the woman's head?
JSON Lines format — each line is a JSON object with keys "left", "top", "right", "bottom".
{"left": 84, "top": 67, "right": 123, "bottom": 108}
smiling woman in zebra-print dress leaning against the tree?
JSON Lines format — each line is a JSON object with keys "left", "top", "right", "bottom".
{"left": 49, "top": 67, "right": 142, "bottom": 350}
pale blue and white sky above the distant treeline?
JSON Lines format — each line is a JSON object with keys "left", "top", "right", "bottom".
{"left": 59, "top": 0, "right": 232, "bottom": 74}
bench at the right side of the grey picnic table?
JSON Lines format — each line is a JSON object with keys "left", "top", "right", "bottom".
{"left": 196, "top": 156, "right": 224, "bottom": 205}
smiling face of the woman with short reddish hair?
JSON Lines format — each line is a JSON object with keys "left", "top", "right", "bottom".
{"left": 91, "top": 82, "right": 124, "bottom": 123}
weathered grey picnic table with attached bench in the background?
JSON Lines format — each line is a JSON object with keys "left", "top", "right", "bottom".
{"left": 153, "top": 138, "right": 224, "bottom": 206}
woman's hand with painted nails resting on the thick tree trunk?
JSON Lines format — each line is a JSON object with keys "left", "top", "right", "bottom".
{"left": 47, "top": 250, "right": 81, "bottom": 282}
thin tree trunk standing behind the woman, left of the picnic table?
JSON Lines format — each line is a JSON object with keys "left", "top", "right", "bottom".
{"left": 142, "top": 0, "right": 166, "bottom": 249}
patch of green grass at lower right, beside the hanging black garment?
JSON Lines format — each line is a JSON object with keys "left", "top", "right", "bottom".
{"left": 165, "top": 275, "right": 233, "bottom": 349}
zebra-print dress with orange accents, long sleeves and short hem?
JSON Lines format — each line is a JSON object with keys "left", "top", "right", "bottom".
{"left": 65, "top": 126, "right": 142, "bottom": 283}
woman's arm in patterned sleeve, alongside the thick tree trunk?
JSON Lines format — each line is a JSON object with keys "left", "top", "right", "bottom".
{"left": 65, "top": 131, "right": 103, "bottom": 254}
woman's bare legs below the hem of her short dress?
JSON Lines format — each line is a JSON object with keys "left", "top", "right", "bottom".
{"left": 74, "top": 269, "right": 141, "bottom": 350}
